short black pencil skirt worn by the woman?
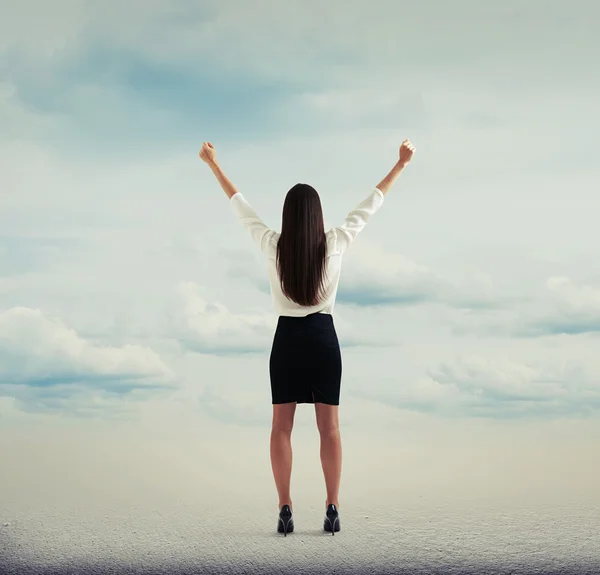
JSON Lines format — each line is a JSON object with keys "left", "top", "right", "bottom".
{"left": 269, "top": 313, "right": 342, "bottom": 405}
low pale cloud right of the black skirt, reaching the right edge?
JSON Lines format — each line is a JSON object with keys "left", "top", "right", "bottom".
{"left": 350, "top": 355, "right": 600, "bottom": 418}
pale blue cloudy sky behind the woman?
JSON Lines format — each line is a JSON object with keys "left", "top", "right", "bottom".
{"left": 0, "top": 0, "right": 600, "bottom": 496}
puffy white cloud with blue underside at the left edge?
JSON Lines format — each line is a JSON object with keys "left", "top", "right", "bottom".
{"left": 0, "top": 307, "right": 176, "bottom": 414}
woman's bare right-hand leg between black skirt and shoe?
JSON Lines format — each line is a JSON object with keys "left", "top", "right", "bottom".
{"left": 315, "top": 403, "right": 342, "bottom": 507}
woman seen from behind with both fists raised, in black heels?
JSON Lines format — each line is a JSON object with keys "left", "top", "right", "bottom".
{"left": 200, "top": 140, "right": 415, "bottom": 536}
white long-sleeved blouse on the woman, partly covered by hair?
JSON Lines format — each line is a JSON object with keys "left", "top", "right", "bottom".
{"left": 230, "top": 188, "right": 384, "bottom": 317}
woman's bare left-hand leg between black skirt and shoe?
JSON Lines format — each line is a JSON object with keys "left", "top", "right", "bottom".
{"left": 271, "top": 403, "right": 296, "bottom": 509}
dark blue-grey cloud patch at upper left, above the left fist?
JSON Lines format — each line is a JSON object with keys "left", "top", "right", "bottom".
{"left": 10, "top": 41, "right": 300, "bottom": 148}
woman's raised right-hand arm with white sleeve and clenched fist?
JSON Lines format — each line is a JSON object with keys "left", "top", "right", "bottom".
{"left": 335, "top": 140, "right": 415, "bottom": 252}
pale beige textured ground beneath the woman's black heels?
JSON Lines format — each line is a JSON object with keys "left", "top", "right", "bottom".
{"left": 0, "top": 420, "right": 600, "bottom": 575}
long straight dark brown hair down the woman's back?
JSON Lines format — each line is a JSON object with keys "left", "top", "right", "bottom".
{"left": 277, "top": 184, "right": 327, "bottom": 306}
